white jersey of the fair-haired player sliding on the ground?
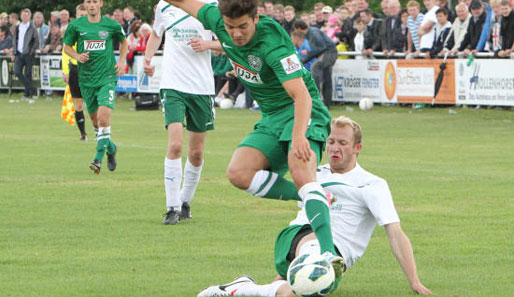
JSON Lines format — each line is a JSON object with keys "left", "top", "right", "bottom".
{"left": 291, "top": 164, "right": 400, "bottom": 267}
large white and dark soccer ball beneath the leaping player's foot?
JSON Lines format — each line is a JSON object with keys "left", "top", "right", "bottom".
{"left": 287, "top": 254, "right": 335, "bottom": 297}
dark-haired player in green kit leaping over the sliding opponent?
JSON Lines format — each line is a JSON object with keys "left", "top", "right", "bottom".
{"left": 162, "top": 0, "right": 344, "bottom": 290}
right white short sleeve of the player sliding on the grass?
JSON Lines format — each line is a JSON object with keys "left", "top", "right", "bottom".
{"left": 363, "top": 180, "right": 400, "bottom": 226}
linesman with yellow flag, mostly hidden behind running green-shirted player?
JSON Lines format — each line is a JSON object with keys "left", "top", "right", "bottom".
{"left": 62, "top": 4, "right": 89, "bottom": 141}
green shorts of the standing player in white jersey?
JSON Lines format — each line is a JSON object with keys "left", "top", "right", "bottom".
{"left": 160, "top": 89, "right": 214, "bottom": 133}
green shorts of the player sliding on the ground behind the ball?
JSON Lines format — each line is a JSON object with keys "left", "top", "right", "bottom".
{"left": 275, "top": 225, "right": 312, "bottom": 279}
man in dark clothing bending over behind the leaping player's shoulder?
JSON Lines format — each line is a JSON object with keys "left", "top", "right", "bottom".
{"left": 293, "top": 20, "right": 337, "bottom": 108}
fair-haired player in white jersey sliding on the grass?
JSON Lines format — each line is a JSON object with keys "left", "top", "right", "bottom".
{"left": 198, "top": 116, "right": 432, "bottom": 297}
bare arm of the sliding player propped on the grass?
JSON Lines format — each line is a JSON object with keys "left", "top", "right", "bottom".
{"left": 385, "top": 223, "right": 432, "bottom": 294}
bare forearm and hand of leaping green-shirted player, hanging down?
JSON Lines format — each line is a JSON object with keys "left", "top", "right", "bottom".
{"left": 282, "top": 77, "right": 312, "bottom": 162}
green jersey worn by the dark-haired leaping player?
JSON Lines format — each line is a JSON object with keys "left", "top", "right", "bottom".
{"left": 198, "top": 4, "right": 330, "bottom": 118}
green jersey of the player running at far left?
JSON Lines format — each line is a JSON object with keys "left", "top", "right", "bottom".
{"left": 63, "top": 16, "right": 125, "bottom": 88}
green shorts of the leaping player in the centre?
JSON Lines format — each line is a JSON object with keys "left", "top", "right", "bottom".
{"left": 238, "top": 105, "right": 330, "bottom": 175}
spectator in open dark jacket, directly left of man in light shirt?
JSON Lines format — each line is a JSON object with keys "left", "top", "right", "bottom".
{"left": 384, "top": 0, "right": 407, "bottom": 56}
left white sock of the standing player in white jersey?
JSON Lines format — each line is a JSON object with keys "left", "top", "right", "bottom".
{"left": 164, "top": 158, "right": 182, "bottom": 211}
